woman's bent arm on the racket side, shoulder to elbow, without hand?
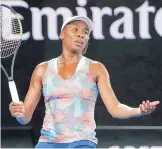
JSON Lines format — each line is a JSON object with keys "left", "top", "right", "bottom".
{"left": 16, "top": 63, "right": 47, "bottom": 124}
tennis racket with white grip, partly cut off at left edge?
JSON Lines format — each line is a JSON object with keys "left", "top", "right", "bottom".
{"left": 0, "top": 4, "right": 23, "bottom": 103}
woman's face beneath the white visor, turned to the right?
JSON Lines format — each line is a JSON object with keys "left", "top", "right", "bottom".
{"left": 60, "top": 21, "right": 89, "bottom": 53}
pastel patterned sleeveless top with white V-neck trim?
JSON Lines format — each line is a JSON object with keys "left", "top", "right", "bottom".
{"left": 39, "top": 56, "right": 98, "bottom": 143}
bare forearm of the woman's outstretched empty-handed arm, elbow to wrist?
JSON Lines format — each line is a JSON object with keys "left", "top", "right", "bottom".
{"left": 111, "top": 103, "right": 140, "bottom": 119}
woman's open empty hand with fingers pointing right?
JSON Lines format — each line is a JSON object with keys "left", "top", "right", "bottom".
{"left": 139, "top": 100, "right": 160, "bottom": 115}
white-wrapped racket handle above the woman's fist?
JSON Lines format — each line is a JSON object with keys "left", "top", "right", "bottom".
{"left": 8, "top": 81, "right": 20, "bottom": 103}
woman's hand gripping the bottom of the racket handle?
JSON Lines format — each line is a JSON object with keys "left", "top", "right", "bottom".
{"left": 9, "top": 101, "right": 25, "bottom": 117}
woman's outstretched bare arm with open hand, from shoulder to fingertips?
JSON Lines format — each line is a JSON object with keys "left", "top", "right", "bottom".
{"left": 96, "top": 63, "right": 159, "bottom": 119}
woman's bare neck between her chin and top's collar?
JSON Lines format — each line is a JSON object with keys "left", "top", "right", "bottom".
{"left": 59, "top": 50, "right": 82, "bottom": 64}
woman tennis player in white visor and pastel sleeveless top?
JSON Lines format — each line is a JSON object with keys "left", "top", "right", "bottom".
{"left": 9, "top": 16, "right": 159, "bottom": 148}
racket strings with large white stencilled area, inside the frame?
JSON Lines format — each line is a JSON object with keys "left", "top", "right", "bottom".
{"left": 0, "top": 6, "right": 21, "bottom": 58}
